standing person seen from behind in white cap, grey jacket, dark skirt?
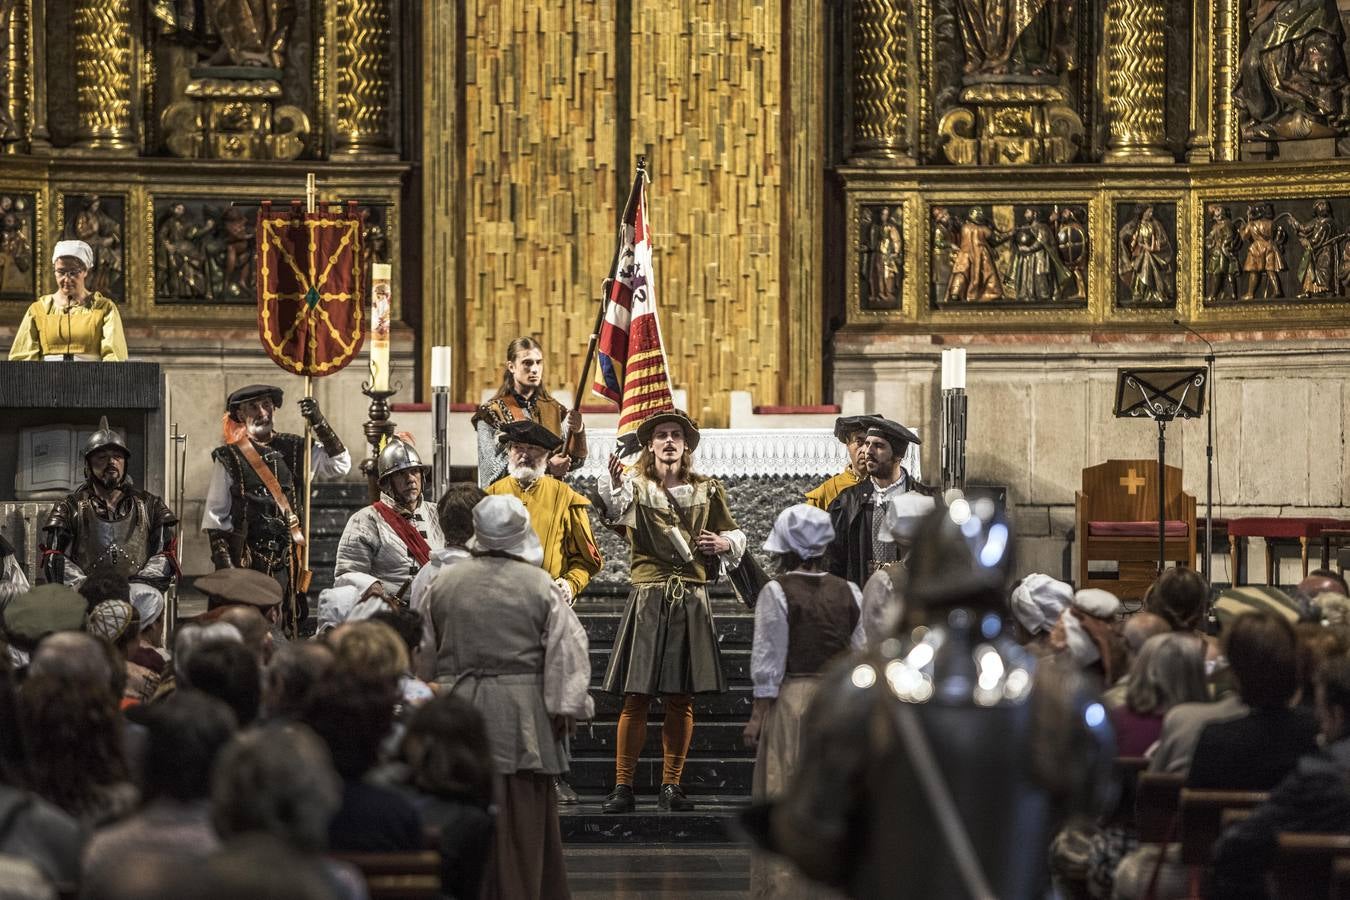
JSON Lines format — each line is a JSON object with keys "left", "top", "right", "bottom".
{"left": 423, "top": 497, "right": 594, "bottom": 897}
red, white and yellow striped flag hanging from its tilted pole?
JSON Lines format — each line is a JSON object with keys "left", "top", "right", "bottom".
{"left": 591, "top": 166, "right": 675, "bottom": 436}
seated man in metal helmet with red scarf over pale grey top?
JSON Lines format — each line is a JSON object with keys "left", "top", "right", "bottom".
{"left": 333, "top": 437, "right": 446, "bottom": 599}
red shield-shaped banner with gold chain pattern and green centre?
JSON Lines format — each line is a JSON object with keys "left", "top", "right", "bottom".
{"left": 258, "top": 202, "right": 366, "bottom": 378}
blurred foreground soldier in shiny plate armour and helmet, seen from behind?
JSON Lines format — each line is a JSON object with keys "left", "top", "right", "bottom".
{"left": 744, "top": 498, "right": 1115, "bottom": 900}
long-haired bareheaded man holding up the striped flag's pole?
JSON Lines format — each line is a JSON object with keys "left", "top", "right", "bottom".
{"left": 473, "top": 337, "right": 586, "bottom": 488}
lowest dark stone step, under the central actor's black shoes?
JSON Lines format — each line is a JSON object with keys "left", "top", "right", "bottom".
{"left": 558, "top": 793, "right": 747, "bottom": 845}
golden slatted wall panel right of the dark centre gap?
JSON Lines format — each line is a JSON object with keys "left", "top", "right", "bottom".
{"left": 632, "top": 0, "right": 783, "bottom": 424}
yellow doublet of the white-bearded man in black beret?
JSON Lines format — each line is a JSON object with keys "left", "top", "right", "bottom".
{"left": 487, "top": 475, "right": 603, "bottom": 596}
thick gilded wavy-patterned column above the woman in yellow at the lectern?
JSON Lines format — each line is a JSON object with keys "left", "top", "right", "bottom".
{"left": 72, "top": 0, "right": 136, "bottom": 154}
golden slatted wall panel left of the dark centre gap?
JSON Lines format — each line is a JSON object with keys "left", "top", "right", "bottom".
{"left": 459, "top": 0, "right": 618, "bottom": 402}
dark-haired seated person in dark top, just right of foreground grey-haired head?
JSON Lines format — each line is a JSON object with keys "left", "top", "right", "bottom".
{"left": 304, "top": 669, "right": 423, "bottom": 853}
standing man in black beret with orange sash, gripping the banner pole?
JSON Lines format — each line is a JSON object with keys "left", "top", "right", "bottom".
{"left": 201, "top": 385, "right": 351, "bottom": 629}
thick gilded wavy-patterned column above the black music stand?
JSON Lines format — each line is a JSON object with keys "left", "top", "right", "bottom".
{"left": 1106, "top": 0, "right": 1173, "bottom": 165}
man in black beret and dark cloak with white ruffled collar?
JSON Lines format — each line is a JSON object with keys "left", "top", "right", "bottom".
{"left": 829, "top": 417, "right": 937, "bottom": 587}
